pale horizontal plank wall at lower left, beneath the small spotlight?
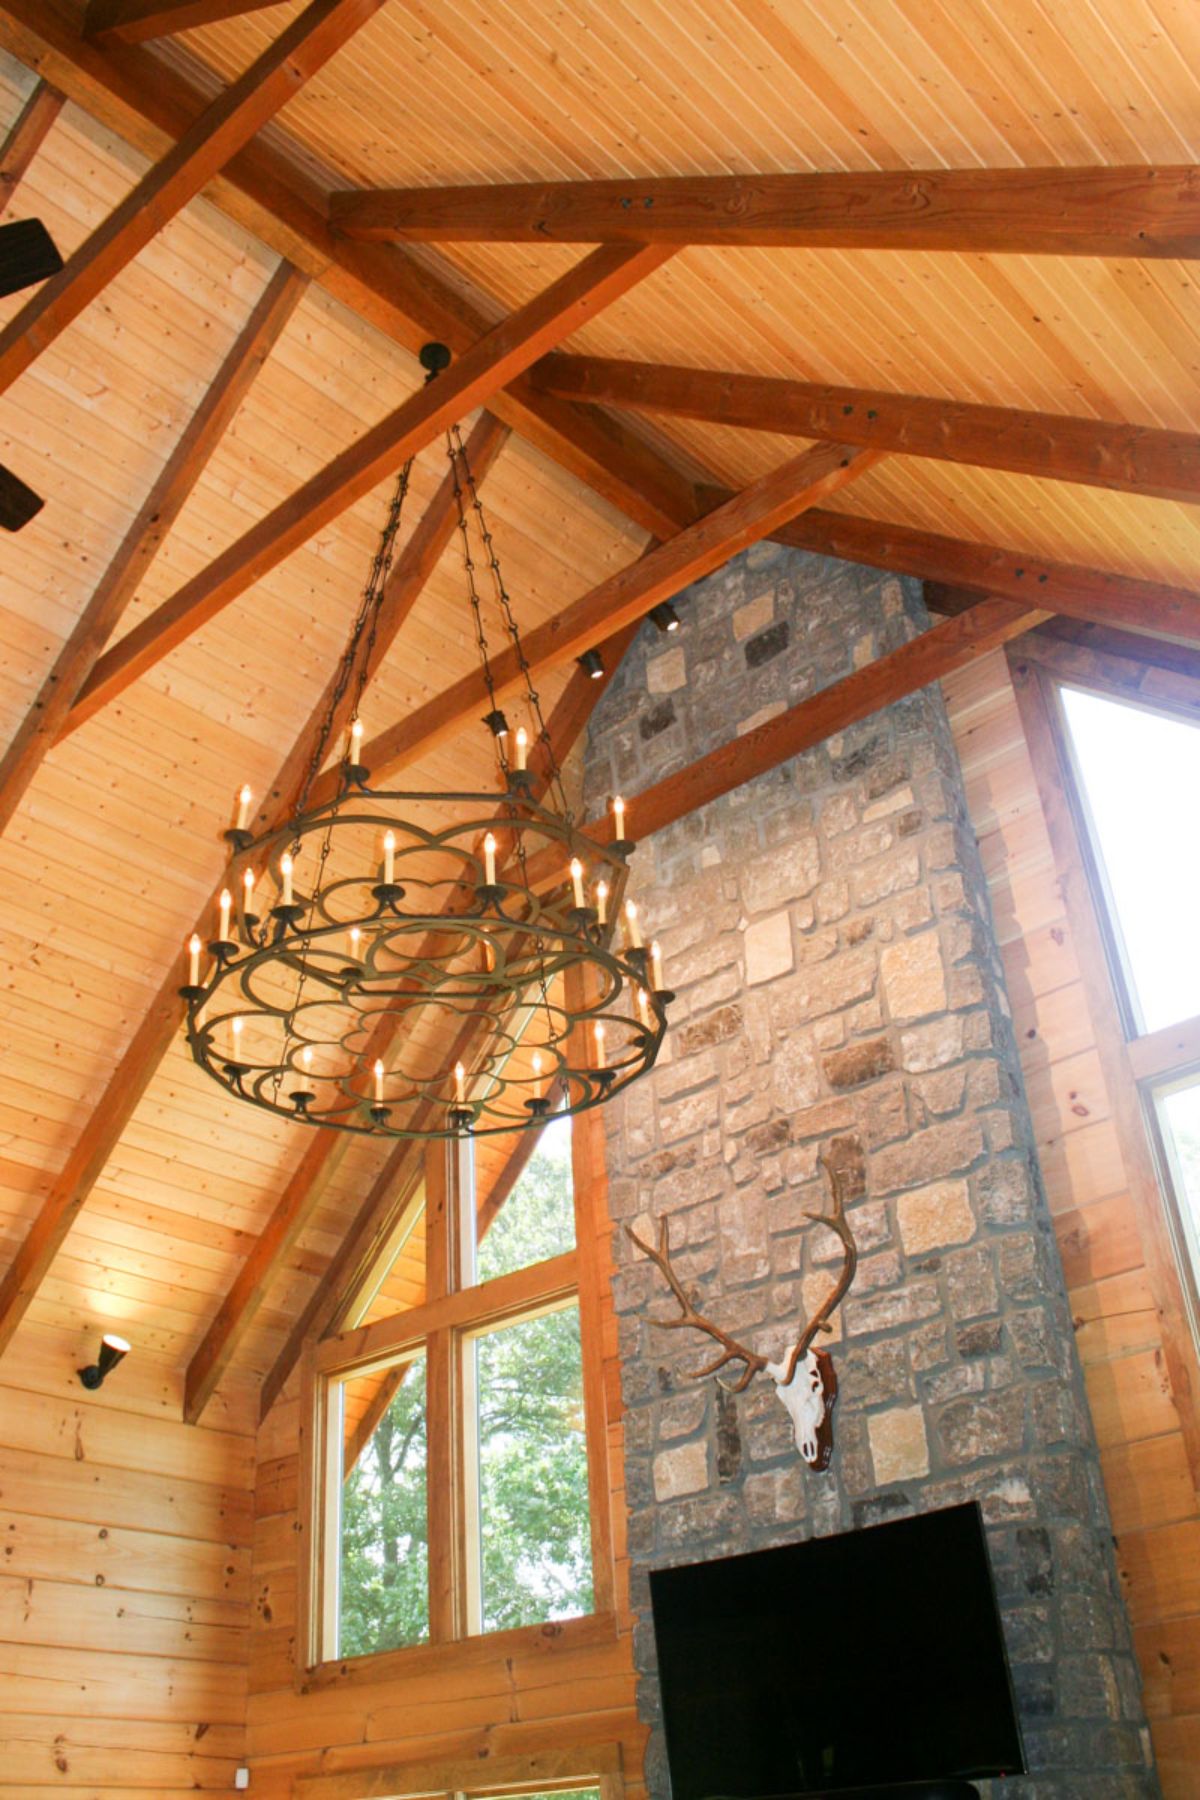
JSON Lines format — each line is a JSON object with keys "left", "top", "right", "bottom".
{"left": 0, "top": 1314, "right": 254, "bottom": 1800}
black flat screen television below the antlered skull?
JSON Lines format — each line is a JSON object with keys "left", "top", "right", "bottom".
{"left": 649, "top": 1503, "right": 1025, "bottom": 1800}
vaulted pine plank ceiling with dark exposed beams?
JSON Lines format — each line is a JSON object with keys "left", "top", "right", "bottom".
{"left": 0, "top": 0, "right": 1200, "bottom": 1432}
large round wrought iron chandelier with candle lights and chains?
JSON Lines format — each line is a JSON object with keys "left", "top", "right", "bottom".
{"left": 180, "top": 344, "right": 671, "bottom": 1138}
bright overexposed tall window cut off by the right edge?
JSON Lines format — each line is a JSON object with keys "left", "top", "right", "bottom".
{"left": 1058, "top": 684, "right": 1200, "bottom": 1332}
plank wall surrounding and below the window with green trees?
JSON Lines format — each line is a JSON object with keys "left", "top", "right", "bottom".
{"left": 248, "top": 1144, "right": 644, "bottom": 1800}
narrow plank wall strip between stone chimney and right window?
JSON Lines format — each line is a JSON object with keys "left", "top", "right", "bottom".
{"left": 943, "top": 652, "right": 1200, "bottom": 1800}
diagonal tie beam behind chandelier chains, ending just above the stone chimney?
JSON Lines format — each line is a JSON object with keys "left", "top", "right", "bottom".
{"left": 347, "top": 445, "right": 880, "bottom": 776}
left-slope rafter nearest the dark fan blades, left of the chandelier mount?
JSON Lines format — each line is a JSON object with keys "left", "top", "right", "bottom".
{"left": 0, "top": 263, "right": 308, "bottom": 832}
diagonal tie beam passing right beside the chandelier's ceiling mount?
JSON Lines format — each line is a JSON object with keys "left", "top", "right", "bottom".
{"left": 63, "top": 245, "right": 671, "bottom": 734}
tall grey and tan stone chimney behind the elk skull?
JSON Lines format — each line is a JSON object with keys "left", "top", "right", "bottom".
{"left": 585, "top": 544, "right": 1159, "bottom": 1800}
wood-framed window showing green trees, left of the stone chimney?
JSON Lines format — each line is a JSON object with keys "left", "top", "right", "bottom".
{"left": 300, "top": 1120, "right": 612, "bottom": 1669}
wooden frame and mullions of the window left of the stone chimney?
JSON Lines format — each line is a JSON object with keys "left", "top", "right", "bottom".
{"left": 295, "top": 1112, "right": 617, "bottom": 1688}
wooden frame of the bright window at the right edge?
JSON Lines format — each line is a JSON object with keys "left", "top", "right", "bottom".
{"left": 1006, "top": 621, "right": 1200, "bottom": 1487}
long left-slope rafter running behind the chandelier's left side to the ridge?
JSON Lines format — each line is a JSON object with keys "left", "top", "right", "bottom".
{"left": 0, "top": 418, "right": 506, "bottom": 1354}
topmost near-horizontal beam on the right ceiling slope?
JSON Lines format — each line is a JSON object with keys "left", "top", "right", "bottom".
{"left": 333, "top": 164, "right": 1200, "bottom": 257}
